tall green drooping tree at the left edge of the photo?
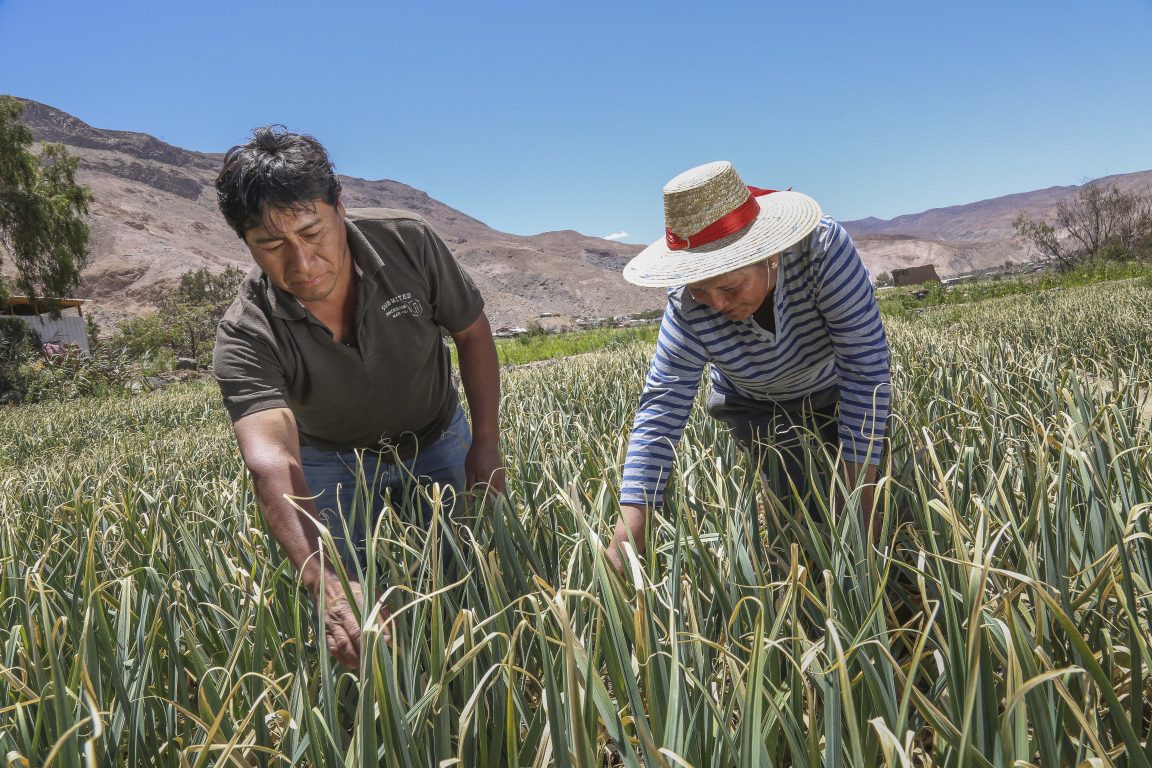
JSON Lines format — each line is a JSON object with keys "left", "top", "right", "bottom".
{"left": 0, "top": 97, "right": 92, "bottom": 312}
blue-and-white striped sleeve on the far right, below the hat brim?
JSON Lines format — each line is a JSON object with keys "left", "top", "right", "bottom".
{"left": 813, "top": 219, "right": 892, "bottom": 464}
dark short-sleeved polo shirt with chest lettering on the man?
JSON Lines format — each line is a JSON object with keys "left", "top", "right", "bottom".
{"left": 213, "top": 208, "right": 484, "bottom": 456}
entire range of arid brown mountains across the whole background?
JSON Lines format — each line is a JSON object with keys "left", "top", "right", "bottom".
{"left": 9, "top": 95, "right": 1152, "bottom": 317}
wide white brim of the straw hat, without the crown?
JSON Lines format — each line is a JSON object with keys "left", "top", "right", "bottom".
{"left": 624, "top": 192, "right": 820, "bottom": 288}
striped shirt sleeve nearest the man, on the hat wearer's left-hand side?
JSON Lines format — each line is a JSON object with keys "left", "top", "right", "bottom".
{"left": 620, "top": 302, "right": 708, "bottom": 508}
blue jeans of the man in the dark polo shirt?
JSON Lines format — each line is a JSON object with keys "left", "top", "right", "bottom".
{"left": 300, "top": 405, "right": 472, "bottom": 573}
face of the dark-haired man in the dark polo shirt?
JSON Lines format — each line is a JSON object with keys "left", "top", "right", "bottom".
{"left": 244, "top": 200, "right": 351, "bottom": 304}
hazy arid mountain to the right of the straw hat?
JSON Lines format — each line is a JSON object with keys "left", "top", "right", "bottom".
{"left": 843, "top": 170, "right": 1152, "bottom": 275}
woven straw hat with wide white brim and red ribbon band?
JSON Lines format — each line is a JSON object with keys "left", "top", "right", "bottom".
{"left": 624, "top": 160, "right": 820, "bottom": 288}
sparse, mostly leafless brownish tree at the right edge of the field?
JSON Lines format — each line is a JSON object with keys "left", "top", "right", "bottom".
{"left": 1013, "top": 183, "right": 1152, "bottom": 271}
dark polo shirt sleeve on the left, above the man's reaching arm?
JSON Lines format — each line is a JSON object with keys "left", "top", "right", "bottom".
{"left": 212, "top": 320, "right": 288, "bottom": 421}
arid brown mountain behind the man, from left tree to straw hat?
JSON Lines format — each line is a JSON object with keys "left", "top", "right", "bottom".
{"left": 9, "top": 101, "right": 664, "bottom": 326}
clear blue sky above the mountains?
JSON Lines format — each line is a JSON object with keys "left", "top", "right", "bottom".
{"left": 0, "top": 0, "right": 1152, "bottom": 242}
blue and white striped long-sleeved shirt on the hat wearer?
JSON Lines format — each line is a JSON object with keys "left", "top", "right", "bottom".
{"left": 620, "top": 216, "right": 890, "bottom": 507}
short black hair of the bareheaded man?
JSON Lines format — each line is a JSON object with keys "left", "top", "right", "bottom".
{"left": 217, "top": 126, "right": 340, "bottom": 239}
